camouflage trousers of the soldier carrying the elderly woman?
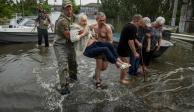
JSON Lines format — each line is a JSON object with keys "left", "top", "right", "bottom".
{"left": 54, "top": 42, "right": 77, "bottom": 86}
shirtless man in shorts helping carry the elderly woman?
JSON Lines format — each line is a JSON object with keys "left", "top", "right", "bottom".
{"left": 91, "top": 12, "right": 113, "bottom": 88}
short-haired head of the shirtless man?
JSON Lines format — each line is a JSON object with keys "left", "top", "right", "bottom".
{"left": 96, "top": 12, "right": 106, "bottom": 25}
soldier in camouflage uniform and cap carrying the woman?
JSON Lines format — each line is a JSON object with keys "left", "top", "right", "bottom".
{"left": 54, "top": 0, "right": 77, "bottom": 94}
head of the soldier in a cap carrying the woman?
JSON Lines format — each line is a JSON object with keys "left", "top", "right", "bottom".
{"left": 62, "top": 0, "right": 73, "bottom": 17}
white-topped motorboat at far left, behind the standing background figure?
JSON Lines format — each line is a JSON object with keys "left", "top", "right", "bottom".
{"left": 0, "top": 17, "right": 54, "bottom": 43}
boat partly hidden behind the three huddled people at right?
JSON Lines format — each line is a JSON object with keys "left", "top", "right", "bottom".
{"left": 113, "top": 33, "right": 173, "bottom": 58}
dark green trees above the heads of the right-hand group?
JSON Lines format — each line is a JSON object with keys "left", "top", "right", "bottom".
{"left": 101, "top": 0, "right": 180, "bottom": 21}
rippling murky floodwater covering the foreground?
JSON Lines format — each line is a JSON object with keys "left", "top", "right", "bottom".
{"left": 0, "top": 41, "right": 194, "bottom": 112}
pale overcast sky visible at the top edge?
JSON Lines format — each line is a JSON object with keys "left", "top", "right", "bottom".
{"left": 48, "top": 0, "right": 97, "bottom": 5}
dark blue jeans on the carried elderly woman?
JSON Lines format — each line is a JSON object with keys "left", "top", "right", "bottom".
{"left": 84, "top": 42, "right": 118, "bottom": 63}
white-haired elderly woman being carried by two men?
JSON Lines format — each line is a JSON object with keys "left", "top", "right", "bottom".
{"left": 70, "top": 13, "right": 130, "bottom": 88}
